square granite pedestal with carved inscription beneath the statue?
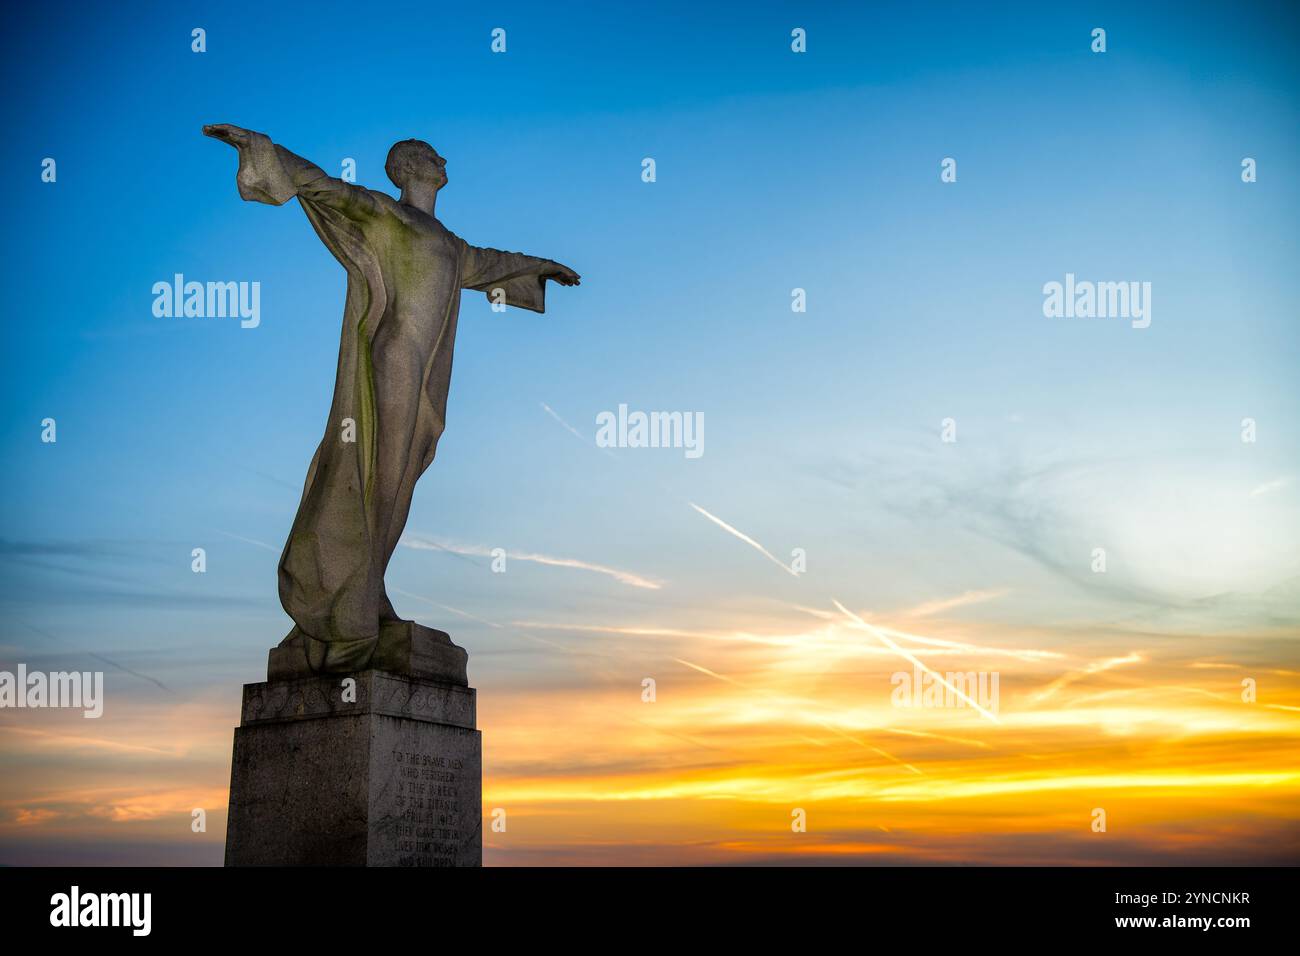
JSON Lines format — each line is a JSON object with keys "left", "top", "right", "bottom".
{"left": 226, "top": 670, "right": 482, "bottom": 866}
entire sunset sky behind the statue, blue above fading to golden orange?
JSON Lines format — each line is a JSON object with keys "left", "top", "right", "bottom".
{"left": 0, "top": 3, "right": 1300, "bottom": 865}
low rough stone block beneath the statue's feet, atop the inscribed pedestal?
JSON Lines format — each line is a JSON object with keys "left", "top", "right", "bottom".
{"left": 267, "top": 620, "right": 469, "bottom": 687}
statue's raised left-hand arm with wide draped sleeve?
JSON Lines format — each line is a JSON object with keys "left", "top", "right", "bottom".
{"left": 203, "top": 122, "right": 380, "bottom": 221}
